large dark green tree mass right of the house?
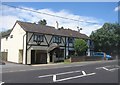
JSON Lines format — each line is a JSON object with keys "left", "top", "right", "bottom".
{"left": 90, "top": 23, "right": 120, "bottom": 55}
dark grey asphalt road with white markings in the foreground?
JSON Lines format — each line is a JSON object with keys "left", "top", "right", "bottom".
{"left": 2, "top": 61, "right": 120, "bottom": 83}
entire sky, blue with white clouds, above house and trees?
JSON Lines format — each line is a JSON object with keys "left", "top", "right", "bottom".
{"left": 0, "top": 2, "right": 120, "bottom": 36}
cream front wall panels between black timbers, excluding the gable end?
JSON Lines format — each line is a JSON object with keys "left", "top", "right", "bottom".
{"left": 27, "top": 33, "right": 72, "bottom": 64}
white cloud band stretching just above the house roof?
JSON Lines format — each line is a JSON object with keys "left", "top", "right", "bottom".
{"left": 0, "top": 5, "right": 103, "bottom": 35}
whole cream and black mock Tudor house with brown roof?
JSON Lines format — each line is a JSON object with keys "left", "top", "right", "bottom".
{"left": 1, "top": 21, "right": 94, "bottom": 64}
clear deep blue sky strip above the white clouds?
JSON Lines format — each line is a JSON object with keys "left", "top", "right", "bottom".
{"left": 6, "top": 2, "right": 118, "bottom": 22}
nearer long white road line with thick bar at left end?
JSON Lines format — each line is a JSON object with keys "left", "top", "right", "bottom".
{"left": 53, "top": 73, "right": 96, "bottom": 82}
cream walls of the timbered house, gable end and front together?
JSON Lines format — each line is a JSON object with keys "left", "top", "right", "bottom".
{"left": 1, "top": 23, "right": 91, "bottom": 64}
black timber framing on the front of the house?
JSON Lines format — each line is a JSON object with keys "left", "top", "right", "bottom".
{"left": 23, "top": 32, "right": 87, "bottom": 64}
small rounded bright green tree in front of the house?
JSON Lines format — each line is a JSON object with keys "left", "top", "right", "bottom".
{"left": 74, "top": 39, "right": 88, "bottom": 55}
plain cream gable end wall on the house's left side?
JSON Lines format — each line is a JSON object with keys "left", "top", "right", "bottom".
{"left": 1, "top": 23, "right": 25, "bottom": 63}
